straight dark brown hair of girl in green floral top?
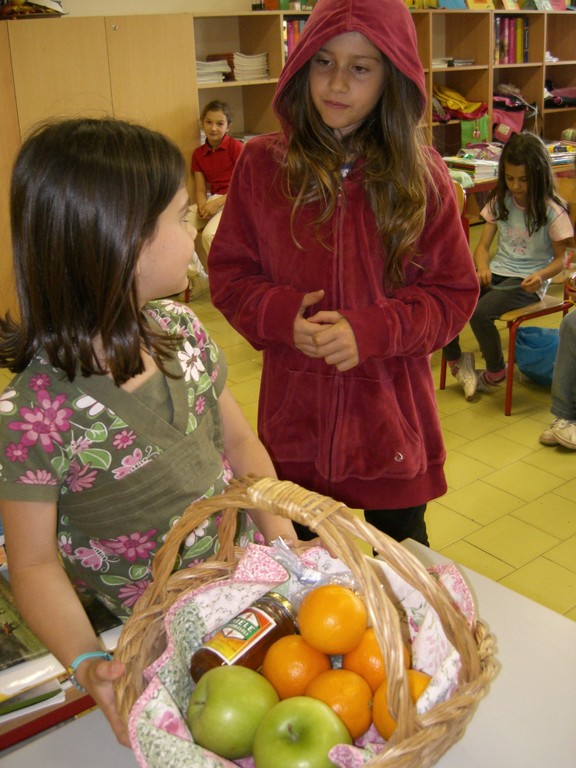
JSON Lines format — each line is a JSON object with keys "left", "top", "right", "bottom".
{"left": 0, "top": 118, "right": 186, "bottom": 385}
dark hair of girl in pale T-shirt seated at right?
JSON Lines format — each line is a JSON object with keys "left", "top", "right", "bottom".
{"left": 487, "top": 133, "right": 568, "bottom": 235}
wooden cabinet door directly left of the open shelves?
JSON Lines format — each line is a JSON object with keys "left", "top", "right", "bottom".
{"left": 106, "top": 13, "right": 198, "bottom": 172}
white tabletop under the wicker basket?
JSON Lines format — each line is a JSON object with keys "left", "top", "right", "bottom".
{"left": 0, "top": 541, "right": 576, "bottom": 768}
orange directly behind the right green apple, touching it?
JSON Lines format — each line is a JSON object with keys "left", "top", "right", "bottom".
{"left": 306, "top": 669, "right": 372, "bottom": 739}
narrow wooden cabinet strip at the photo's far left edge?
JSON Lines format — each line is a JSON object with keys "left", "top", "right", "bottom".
{"left": 0, "top": 21, "right": 20, "bottom": 314}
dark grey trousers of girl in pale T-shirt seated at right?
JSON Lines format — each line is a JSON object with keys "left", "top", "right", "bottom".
{"left": 470, "top": 288, "right": 538, "bottom": 373}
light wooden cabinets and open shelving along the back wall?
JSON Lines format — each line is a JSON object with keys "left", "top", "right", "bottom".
{"left": 0, "top": 9, "right": 576, "bottom": 311}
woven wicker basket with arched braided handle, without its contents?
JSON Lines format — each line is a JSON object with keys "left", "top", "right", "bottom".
{"left": 115, "top": 478, "right": 497, "bottom": 768}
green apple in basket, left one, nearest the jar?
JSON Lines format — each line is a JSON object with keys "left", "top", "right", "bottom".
{"left": 188, "top": 666, "right": 278, "bottom": 760}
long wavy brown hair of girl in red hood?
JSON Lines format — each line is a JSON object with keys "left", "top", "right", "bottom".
{"left": 277, "top": 56, "right": 440, "bottom": 288}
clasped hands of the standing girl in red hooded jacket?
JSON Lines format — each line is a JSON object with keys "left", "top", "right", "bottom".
{"left": 294, "top": 290, "right": 360, "bottom": 372}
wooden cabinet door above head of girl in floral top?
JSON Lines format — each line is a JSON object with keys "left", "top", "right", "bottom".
{"left": 9, "top": 17, "right": 112, "bottom": 137}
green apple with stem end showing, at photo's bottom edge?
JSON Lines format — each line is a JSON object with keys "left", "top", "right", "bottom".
{"left": 253, "top": 696, "right": 352, "bottom": 768}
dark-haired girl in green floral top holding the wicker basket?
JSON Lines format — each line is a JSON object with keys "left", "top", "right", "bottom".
{"left": 0, "top": 119, "right": 295, "bottom": 744}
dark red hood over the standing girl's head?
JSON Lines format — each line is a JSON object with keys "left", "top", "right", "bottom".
{"left": 274, "top": 0, "right": 427, "bottom": 125}
